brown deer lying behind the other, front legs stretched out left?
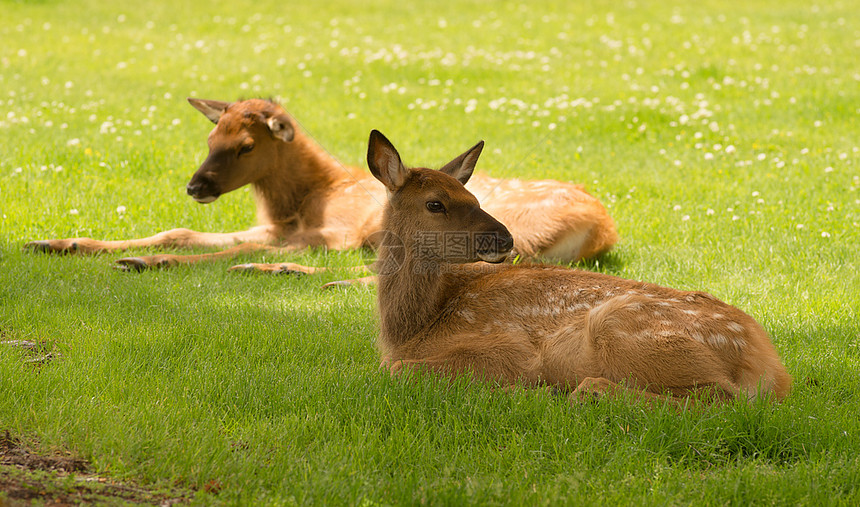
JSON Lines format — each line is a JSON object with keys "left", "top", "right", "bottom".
{"left": 26, "top": 98, "right": 617, "bottom": 272}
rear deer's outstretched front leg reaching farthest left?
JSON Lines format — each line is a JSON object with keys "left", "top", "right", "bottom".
{"left": 24, "top": 225, "right": 274, "bottom": 254}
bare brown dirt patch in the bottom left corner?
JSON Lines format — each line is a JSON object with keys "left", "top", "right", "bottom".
{"left": 0, "top": 430, "right": 193, "bottom": 507}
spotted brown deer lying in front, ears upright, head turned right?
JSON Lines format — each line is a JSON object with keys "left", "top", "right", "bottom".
{"left": 367, "top": 131, "right": 791, "bottom": 404}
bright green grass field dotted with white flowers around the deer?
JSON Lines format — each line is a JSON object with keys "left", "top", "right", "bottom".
{"left": 0, "top": 0, "right": 860, "bottom": 505}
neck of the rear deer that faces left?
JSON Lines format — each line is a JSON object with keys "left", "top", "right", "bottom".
{"left": 253, "top": 130, "right": 351, "bottom": 224}
